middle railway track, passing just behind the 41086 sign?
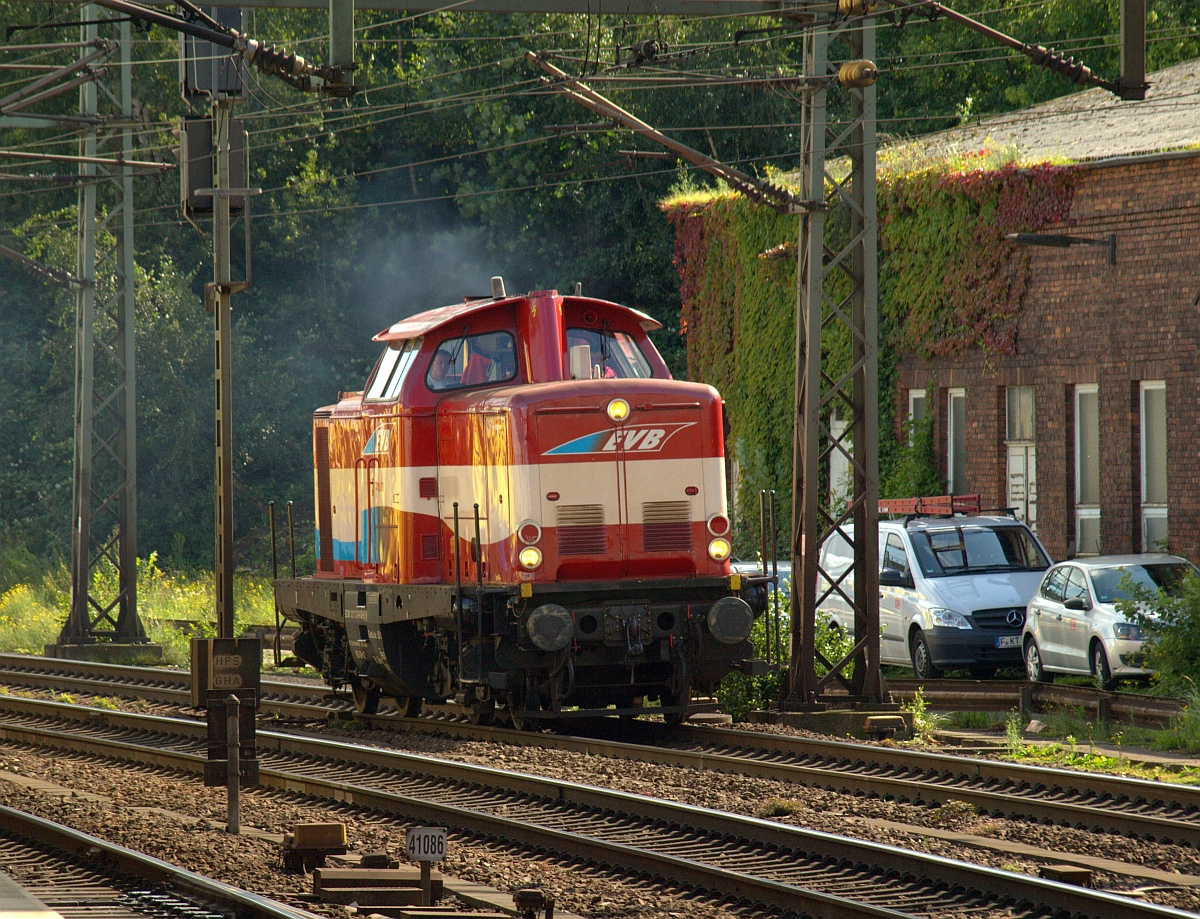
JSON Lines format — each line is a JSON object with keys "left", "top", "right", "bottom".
{"left": 0, "top": 697, "right": 1194, "bottom": 919}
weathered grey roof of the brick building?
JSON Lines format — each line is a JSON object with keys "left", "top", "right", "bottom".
{"left": 916, "top": 59, "right": 1200, "bottom": 161}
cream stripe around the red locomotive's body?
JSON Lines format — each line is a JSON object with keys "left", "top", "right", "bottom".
{"left": 319, "top": 457, "right": 726, "bottom": 543}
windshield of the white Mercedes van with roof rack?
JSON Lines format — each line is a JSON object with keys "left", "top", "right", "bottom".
{"left": 911, "top": 525, "right": 1050, "bottom": 577}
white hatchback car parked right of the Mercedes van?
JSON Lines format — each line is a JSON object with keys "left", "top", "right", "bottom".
{"left": 1021, "top": 553, "right": 1196, "bottom": 689}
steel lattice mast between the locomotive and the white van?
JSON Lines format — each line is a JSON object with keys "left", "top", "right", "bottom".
{"left": 781, "top": 10, "right": 883, "bottom": 710}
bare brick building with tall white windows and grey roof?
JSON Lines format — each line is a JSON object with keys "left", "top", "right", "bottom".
{"left": 895, "top": 61, "right": 1200, "bottom": 561}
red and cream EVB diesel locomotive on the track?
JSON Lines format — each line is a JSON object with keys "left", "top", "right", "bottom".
{"left": 275, "top": 278, "right": 766, "bottom": 726}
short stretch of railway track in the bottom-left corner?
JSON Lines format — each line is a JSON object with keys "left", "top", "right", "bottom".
{"left": 0, "top": 806, "right": 318, "bottom": 919}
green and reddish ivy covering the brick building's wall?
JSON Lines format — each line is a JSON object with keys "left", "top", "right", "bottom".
{"left": 662, "top": 152, "right": 1075, "bottom": 553}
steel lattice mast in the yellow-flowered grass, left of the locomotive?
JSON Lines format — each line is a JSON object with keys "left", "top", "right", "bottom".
{"left": 54, "top": 4, "right": 154, "bottom": 657}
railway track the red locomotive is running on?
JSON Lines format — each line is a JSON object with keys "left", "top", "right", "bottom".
{"left": 0, "top": 655, "right": 1200, "bottom": 849}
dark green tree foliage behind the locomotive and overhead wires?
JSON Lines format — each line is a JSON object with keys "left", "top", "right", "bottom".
{"left": 0, "top": 0, "right": 1196, "bottom": 571}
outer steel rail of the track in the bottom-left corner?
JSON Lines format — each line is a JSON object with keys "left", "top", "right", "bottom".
{"left": 0, "top": 806, "right": 320, "bottom": 919}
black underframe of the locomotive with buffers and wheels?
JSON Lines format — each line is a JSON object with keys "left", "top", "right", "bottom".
{"left": 278, "top": 578, "right": 761, "bottom": 721}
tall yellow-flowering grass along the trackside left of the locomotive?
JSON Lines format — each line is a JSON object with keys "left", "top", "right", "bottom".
{"left": 0, "top": 553, "right": 275, "bottom": 666}
